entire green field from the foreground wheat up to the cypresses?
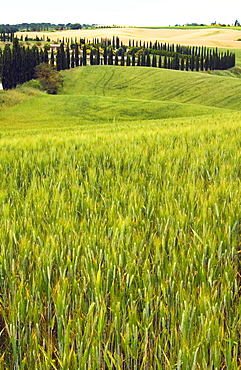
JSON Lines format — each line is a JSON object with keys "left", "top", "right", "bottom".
{"left": 0, "top": 66, "right": 241, "bottom": 370}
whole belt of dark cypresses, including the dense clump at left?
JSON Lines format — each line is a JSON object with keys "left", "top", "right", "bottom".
{"left": 0, "top": 37, "right": 235, "bottom": 89}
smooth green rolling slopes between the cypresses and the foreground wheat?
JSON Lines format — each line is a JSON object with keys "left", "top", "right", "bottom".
{"left": 0, "top": 66, "right": 241, "bottom": 134}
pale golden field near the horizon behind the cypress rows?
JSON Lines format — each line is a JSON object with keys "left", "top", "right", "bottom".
{"left": 17, "top": 28, "right": 241, "bottom": 49}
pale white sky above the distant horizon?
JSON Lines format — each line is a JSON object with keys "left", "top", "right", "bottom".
{"left": 0, "top": 0, "right": 241, "bottom": 27}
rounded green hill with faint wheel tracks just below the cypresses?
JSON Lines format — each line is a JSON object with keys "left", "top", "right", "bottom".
{"left": 63, "top": 66, "right": 241, "bottom": 110}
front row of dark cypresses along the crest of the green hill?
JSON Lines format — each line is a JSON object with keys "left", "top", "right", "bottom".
{"left": 53, "top": 43, "right": 235, "bottom": 71}
